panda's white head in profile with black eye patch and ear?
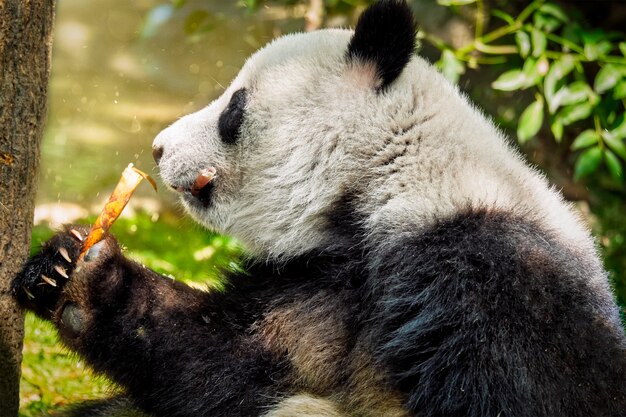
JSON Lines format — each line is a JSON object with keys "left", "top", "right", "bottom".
{"left": 153, "top": 0, "right": 415, "bottom": 258}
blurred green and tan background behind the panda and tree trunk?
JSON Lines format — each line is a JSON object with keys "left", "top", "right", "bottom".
{"left": 21, "top": 0, "right": 626, "bottom": 416}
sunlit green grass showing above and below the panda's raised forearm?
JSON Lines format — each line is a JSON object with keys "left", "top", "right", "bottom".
{"left": 19, "top": 212, "right": 241, "bottom": 417}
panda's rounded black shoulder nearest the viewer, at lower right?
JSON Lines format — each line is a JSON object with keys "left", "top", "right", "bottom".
{"left": 369, "top": 211, "right": 626, "bottom": 417}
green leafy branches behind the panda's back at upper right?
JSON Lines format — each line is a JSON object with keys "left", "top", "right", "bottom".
{"left": 428, "top": 0, "right": 626, "bottom": 186}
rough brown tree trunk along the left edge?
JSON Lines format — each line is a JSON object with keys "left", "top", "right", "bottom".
{"left": 0, "top": 0, "right": 55, "bottom": 417}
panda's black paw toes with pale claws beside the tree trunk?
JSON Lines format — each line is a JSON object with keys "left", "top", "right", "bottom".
{"left": 12, "top": 226, "right": 89, "bottom": 318}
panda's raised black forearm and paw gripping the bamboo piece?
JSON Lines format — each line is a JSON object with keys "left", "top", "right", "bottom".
{"left": 13, "top": 228, "right": 281, "bottom": 416}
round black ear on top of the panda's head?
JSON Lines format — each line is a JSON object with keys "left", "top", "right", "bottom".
{"left": 347, "top": 0, "right": 416, "bottom": 90}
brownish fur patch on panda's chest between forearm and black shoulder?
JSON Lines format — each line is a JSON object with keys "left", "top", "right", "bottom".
{"left": 255, "top": 292, "right": 407, "bottom": 417}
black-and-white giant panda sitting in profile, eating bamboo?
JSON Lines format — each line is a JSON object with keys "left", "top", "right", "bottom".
{"left": 13, "top": 0, "right": 626, "bottom": 417}
